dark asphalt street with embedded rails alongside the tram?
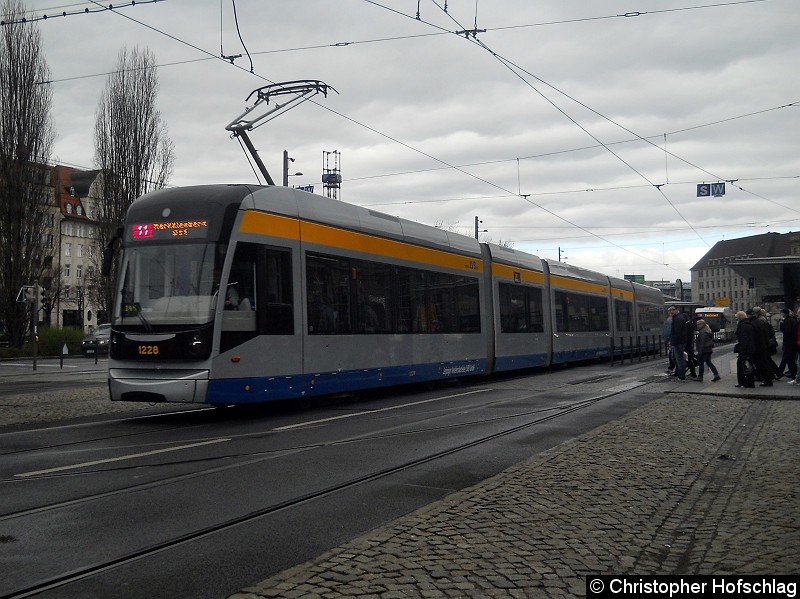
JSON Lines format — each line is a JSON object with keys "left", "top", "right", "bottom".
{"left": 0, "top": 361, "right": 663, "bottom": 597}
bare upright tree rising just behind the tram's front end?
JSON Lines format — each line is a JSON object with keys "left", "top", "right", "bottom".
{"left": 92, "top": 47, "right": 174, "bottom": 314}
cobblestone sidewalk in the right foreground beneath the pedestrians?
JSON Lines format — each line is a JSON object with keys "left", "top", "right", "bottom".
{"left": 231, "top": 367, "right": 800, "bottom": 599}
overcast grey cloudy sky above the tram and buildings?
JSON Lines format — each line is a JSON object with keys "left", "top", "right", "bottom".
{"left": 7, "top": 0, "right": 800, "bottom": 281}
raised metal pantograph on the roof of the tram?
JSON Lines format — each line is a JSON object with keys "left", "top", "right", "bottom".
{"left": 225, "top": 79, "right": 339, "bottom": 185}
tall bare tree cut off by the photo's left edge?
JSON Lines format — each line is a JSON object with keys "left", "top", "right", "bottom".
{"left": 0, "top": 0, "right": 55, "bottom": 346}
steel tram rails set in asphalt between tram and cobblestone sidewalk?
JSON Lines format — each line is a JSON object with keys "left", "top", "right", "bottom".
{"left": 0, "top": 370, "right": 652, "bottom": 599}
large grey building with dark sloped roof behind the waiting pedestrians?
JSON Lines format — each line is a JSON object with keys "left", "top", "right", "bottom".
{"left": 691, "top": 232, "right": 800, "bottom": 313}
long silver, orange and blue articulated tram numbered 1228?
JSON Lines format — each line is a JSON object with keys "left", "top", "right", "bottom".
{"left": 109, "top": 185, "right": 664, "bottom": 404}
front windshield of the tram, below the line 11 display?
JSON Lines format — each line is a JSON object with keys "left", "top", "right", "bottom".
{"left": 115, "top": 243, "right": 225, "bottom": 329}
